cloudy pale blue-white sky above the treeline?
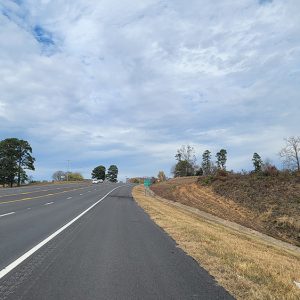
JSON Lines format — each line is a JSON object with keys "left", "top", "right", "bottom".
{"left": 0, "top": 0, "right": 300, "bottom": 179}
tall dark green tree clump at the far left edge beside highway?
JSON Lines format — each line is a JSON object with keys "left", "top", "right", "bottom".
{"left": 0, "top": 138, "right": 35, "bottom": 186}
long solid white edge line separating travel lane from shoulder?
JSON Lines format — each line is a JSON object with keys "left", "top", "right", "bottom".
{"left": 0, "top": 185, "right": 126, "bottom": 279}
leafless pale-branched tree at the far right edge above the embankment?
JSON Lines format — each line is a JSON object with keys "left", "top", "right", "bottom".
{"left": 279, "top": 136, "right": 300, "bottom": 172}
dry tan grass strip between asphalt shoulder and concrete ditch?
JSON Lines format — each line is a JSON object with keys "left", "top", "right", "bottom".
{"left": 133, "top": 186, "right": 300, "bottom": 300}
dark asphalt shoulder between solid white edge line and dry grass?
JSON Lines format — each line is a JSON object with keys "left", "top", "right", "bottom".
{"left": 0, "top": 186, "right": 232, "bottom": 300}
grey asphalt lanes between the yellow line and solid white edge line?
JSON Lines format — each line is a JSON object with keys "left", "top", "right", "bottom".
{"left": 0, "top": 184, "right": 119, "bottom": 270}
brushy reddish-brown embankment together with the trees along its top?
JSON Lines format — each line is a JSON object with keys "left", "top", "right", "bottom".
{"left": 151, "top": 137, "right": 300, "bottom": 246}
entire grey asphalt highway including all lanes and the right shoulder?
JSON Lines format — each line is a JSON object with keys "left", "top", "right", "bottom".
{"left": 0, "top": 183, "right": 233, "bottom": 300}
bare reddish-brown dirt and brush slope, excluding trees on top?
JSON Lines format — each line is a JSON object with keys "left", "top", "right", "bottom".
{"left": 151, "top": 176, "right": 300, "bottom": 246}
